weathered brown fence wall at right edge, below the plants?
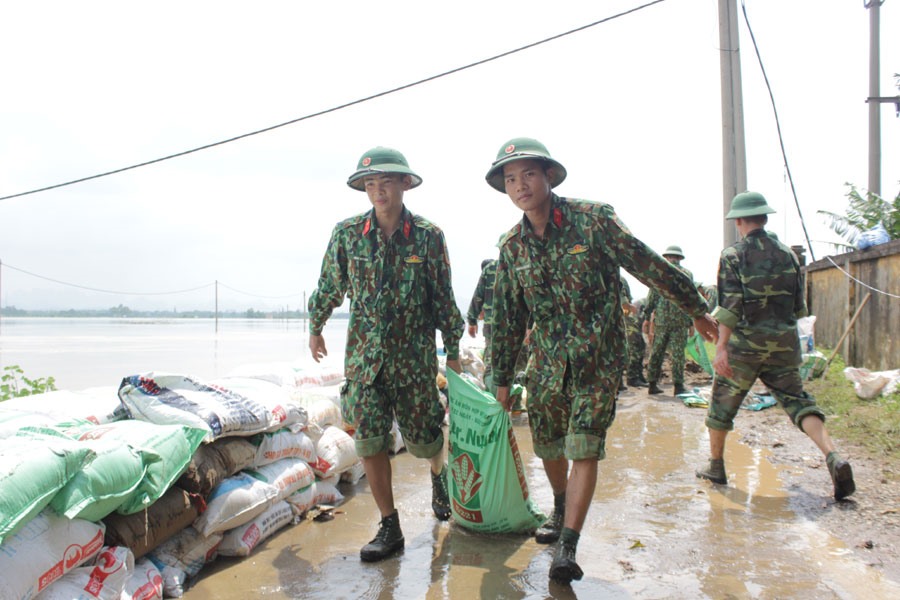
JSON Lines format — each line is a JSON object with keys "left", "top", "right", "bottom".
{"left": 804, "top": 240, "right": 900, "bottom": 371}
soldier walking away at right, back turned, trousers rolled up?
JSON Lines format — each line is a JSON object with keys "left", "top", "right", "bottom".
{"left": 697, "top": 192, "right": 856, "bottom": 500}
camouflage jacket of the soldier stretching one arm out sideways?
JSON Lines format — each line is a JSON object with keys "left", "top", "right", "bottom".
{"left": 491, "top": 194, "right": 706, "bottom": 390}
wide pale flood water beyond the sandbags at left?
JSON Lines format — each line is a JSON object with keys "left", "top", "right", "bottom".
{"left": 0, "top": 317, "right": 347, "bottom": 391}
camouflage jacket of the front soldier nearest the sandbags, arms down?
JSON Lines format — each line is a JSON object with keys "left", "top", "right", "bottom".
{"left": 309, "top": 207, "right": 463, "bottom": 385}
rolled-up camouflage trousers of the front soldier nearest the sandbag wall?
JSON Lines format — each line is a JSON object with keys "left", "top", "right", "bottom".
{"left": 341, "top": 374, "right": 445, "bottom": 458}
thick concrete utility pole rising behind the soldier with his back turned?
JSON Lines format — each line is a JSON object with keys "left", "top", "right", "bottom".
{"left": 719, "top": 0, "right": 747, "bottom": 247}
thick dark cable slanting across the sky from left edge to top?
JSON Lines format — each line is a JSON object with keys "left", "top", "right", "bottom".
{"left": 0, "top": 0, "right": 665, "bottom": 200}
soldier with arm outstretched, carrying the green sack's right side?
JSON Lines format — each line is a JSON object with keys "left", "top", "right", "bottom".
{"left": 486, "top": 138, "right": 716, "bottom": 583}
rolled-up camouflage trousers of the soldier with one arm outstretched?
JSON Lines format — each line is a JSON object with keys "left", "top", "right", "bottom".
{"left": 526, "top": 371, "right": 622, "bottom": 460}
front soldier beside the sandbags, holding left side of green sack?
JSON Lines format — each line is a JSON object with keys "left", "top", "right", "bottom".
{"left": 309, "top": 147, "right": 463, "bottom": 561}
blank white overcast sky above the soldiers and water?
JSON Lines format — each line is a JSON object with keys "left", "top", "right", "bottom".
{"left": 0, "top": 0, "right": 900, "bottom": 311}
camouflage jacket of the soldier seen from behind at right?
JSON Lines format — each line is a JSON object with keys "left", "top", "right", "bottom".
{"left": 713, "top": 229, "right": 807, "bottom": 366}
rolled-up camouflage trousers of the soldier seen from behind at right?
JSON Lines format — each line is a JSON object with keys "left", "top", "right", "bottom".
{"left": 706, "top": 358, "right": 825, "bottom": 431}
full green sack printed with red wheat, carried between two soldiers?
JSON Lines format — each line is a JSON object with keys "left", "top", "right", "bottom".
{"left": 447, "top": 369, "right": 547, "bottom": 533}
